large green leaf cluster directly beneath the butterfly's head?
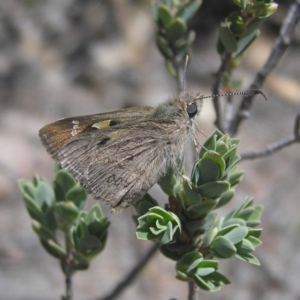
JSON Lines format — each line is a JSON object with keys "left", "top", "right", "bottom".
{"left": 135, "top": 130, "right": 262, "bottom": 291}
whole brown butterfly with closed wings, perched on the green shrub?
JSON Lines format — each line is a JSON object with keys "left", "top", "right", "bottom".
{"left": 39, "top": 93, "right": 202, "bottom": 212}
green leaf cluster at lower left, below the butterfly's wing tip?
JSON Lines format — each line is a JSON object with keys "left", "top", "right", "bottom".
{"left": 19, "top": 168, "right": 109, "bottom": 270}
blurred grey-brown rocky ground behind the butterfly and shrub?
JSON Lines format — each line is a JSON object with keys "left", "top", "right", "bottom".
{"left": 0, "top": 0, "right": 300, "bottom": 300}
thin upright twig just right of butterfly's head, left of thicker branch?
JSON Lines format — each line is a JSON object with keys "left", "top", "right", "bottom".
{"left": 212, "top": 53, "right": 231, "bottom": 132}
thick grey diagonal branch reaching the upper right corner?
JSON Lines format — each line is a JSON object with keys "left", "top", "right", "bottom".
{"left": 229, "top": 0, "right": 300, "bottom": 136}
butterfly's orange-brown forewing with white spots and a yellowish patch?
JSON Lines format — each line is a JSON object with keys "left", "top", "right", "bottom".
{"left": 39, "top": 106, "right": 153, "bottom": 159}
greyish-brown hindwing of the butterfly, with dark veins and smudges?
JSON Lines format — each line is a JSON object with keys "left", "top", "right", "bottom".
{"left": 57, "top": 120, "right": 166, "bottom": 212}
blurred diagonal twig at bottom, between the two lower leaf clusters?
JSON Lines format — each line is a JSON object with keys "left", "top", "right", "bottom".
{"left": 99, "top": 243, "right": 160, "bottom": 300}
